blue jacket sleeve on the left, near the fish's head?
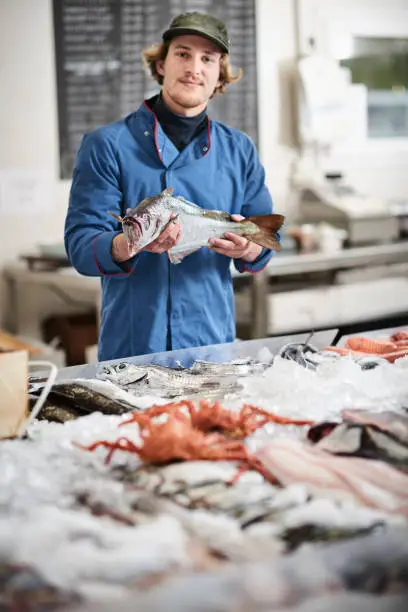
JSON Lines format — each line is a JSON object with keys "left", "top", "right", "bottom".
{"left": 64, "top": 131, "right": 138, "bottom": 276}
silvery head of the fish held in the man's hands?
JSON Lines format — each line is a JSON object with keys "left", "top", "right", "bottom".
{"left": 122, "top": 189, "right": 172, "bottom": 251}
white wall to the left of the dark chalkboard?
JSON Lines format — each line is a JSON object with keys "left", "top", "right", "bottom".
{"left": 0, "top": 0, "right": 69, "bottom": 324}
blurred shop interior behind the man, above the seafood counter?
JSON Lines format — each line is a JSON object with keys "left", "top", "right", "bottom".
{"left": 0, "top": 0, "right": 408, "bottom": 365}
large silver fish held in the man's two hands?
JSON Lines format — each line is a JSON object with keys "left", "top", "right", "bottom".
{"left": 109, "top": 187, "right": 284, "bottom": 264}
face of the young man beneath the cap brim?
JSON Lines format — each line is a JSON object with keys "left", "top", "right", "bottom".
{"left": 157, "top": 35, "right": 221, "bottom": 116}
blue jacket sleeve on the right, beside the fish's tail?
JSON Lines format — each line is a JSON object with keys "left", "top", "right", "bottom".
{"left": 234, "top": 140, "right": 273, "bottom": 273}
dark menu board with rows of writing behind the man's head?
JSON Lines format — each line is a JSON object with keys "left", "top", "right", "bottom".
{"left": 54, "top": 0, "right": 258, "bottom": 179}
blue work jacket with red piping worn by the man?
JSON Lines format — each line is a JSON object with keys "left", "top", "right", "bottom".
{"left": 65, "top": 101, "right": 272, "bottom": 361}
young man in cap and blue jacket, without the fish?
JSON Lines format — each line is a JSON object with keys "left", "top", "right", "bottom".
{"left": 65, "top": 12, "right": 272, "bottom": 360}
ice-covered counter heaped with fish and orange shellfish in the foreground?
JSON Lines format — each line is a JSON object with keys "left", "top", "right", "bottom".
{"left": 0, "top": 329, "right": 408, "bottom": 612}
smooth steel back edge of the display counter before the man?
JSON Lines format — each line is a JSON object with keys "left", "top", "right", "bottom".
{"left": 57, "top": 329, "right": 338, "bottom": 381}
